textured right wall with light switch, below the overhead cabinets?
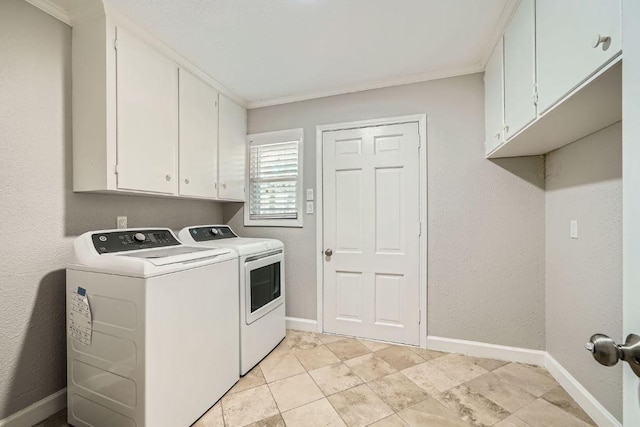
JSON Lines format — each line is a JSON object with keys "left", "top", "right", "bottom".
{"left": 546, "top": 123, "right": 626, "bottom": 419}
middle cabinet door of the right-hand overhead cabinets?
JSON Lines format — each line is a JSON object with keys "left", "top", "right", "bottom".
{"left": 504, "top": 0, "right": 536, "bottom": 140}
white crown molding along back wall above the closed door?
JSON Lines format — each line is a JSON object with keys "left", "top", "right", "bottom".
{"left": 247, "top": 64, "right": 484, "bottom": 109}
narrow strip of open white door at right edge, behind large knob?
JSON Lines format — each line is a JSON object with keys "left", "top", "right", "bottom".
{"left": 622, "top": 0, "right": 640, "bottom": 426}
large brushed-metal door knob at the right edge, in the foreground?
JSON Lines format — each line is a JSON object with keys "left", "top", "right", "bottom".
{"left": 585, "top": 334, "right": 640, "bottom": 377}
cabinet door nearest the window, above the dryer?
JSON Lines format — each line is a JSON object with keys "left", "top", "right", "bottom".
{"left": 218, "top": 94, "right": 247, "bottom": 201}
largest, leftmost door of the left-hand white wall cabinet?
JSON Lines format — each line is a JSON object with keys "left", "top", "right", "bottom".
{"left": 116, "top": 27, "right": 178, "bottom": 194}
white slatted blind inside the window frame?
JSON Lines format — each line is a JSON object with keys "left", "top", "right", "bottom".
{"left": 249, "top": 141, "right": 299, "bottom": 219}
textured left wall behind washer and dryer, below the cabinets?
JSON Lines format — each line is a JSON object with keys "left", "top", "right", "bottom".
{"left": 0, "top": 0, "right": 222, "bottom": 420}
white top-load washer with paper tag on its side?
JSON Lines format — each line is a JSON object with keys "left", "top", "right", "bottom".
{"left": 67, "top": 228, "right": 239, "bottom": 427}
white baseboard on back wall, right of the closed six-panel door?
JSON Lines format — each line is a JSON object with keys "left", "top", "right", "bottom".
{"left": 427, "top": 336, "right": 547, "bottom": 366}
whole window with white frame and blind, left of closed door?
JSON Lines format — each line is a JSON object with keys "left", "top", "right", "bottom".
{"left": 244, "top": 129, "right": 303, "bottom": 227}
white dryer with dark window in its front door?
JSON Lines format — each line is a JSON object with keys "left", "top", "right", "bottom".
{"left": 178, "top": 225, "right": 286, "bottom": 375}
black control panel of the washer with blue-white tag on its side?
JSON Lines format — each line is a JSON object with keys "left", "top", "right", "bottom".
{"left": 91, "top": 229, "right": 180, "bottom": 254}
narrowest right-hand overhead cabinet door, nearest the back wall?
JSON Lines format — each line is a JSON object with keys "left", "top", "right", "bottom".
{"left": 484, "top": 38, "right": 504, "bottom": 154}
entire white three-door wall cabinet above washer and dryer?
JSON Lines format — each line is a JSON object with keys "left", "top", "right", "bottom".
{"left": 72, "top": 15, "right": 247, "bottom": 201}
